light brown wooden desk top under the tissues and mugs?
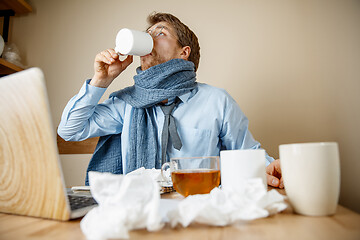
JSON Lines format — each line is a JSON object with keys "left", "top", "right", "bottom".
{"left": 0, "top": 189, "right": 360, "bottom": 240}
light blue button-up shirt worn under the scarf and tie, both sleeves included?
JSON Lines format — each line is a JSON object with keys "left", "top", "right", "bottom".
{"left": 58, "top": 80, "right": 274, "bottom": 172}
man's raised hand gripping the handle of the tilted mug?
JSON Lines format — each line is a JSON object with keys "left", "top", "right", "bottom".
{"left": 90, "top": 49, "right": 133, "bottom": 88}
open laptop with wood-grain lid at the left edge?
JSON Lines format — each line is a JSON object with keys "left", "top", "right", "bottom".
{"left": 0, "top": 68, "right": 96, "bottom": 221}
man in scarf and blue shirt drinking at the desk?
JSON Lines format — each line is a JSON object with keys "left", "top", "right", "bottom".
{"left": 58, "top": 13, "right": 283, "bottom": 187}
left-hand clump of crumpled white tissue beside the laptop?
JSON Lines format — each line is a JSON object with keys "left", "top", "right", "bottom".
{"left": 80, "top": 170, "right": 164, "bottom": 239}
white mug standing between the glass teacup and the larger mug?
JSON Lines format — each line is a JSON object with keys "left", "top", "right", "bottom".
{"left": 220, "top": 149, "right": 267, "bottom": 190}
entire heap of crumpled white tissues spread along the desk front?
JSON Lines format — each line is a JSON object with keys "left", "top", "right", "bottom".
{"left": 80, "top": 169, "right": 287, "bottom": 239}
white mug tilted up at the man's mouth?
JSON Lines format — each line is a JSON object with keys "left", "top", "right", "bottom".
{"left": 115, "top": 28, "right": 154, "bottom": 56}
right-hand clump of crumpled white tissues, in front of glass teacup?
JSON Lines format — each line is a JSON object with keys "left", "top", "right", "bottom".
{"left": 167, "top": 178, "right": 287, "bottom": 227}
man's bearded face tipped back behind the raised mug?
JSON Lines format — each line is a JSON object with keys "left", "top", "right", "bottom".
{"left": 140, "top": 22, "right": 182, "bottom": 71}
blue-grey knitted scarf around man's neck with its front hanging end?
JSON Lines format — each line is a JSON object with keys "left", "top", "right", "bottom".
{"left": 110, "top": 59, "right": 197, "bottom": 172}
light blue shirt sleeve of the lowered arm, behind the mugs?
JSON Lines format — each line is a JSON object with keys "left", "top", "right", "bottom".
{"left": 220, "top": 92, "right": 274, "bottom": 165}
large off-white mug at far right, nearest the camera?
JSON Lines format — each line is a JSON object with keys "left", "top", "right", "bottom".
{"left": 279, "top": 142, "right": 340, "bottom": 216}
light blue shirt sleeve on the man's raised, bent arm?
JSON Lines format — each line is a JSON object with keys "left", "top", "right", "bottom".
{"left": 58, "top": 80, "right": 125, "bottom": 141}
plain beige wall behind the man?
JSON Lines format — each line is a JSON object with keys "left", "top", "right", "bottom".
{"left": 11, "top": 0, "right": 360, "bottom": 212}
